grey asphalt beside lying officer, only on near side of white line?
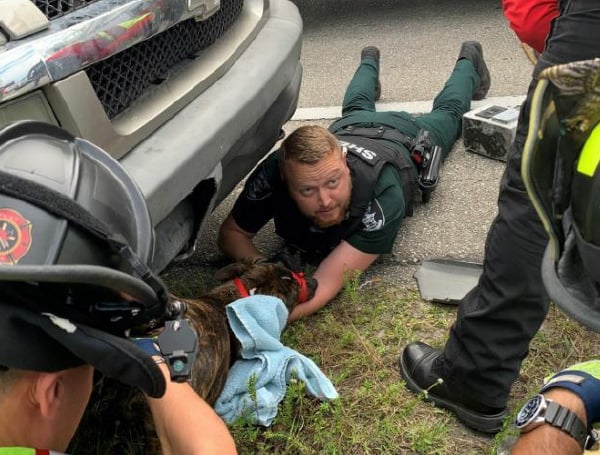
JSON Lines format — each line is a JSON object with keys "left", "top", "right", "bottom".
{"left": 194, "top": 116, "right": 504, "bottom": 289}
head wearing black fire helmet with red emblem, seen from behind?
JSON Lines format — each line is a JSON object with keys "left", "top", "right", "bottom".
{"left": 0, "top": 122, "right": 166, "bottom": 450}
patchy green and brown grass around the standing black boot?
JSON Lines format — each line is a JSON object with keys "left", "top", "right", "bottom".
{"left": 72, "top": 269, "right": 599, "bottom": 455}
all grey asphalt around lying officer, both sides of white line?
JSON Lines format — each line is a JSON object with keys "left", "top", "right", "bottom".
{"left": 193, "top": 0, "right": 532, "bottom": 296}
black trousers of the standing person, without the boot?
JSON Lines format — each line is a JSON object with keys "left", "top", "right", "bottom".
{"left": 434, "top": 0, "right": 600, "bottom": 407}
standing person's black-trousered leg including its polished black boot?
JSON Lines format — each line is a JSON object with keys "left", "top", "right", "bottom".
{"left": 400, "top": 71, "right": 548, "bottom": 433}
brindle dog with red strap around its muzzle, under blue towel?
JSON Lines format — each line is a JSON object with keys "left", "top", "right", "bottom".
{"left": 69, "top": 262, "right": 317, "bottom": 455}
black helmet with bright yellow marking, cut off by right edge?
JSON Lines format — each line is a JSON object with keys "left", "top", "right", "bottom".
{"left": 522, "top": 59, "right": 600, "bottom": 331}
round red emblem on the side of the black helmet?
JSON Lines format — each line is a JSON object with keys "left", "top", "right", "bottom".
{"left": 0, "top": 209, "right": 31, "bottom": 264}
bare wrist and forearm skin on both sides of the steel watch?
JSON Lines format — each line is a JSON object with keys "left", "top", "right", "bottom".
{"left": 511, "top": 388, "right": 587, "bottom": 455}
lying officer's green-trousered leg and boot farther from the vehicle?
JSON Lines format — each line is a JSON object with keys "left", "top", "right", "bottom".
{"left": 416, "top": 41, "right": 490, "bottom": 158}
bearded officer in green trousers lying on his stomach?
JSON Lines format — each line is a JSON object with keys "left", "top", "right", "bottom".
{"left": 218, "top": 41, "right": 490, "bottom": 321}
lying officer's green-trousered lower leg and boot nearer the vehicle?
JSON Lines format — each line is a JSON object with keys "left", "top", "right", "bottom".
{"left": 342, "top": 46, "right": 381, "bottom": 116}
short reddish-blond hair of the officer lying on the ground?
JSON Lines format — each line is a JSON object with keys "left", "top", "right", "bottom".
{"left": 280, "top": 125, "right": 341, "bottom": 164}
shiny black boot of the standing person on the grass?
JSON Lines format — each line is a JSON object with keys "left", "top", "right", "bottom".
{"left": 398, "top": 342, "right": 508, "bottom": 433}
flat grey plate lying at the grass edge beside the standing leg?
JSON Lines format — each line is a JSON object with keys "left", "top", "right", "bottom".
{"left": 414, "top": 259, "right": 483, "bottom": 305}
